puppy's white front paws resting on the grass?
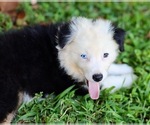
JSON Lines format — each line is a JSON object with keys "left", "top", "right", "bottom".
{"left": 101, "top": 64, "right": 137, "bottom": 92}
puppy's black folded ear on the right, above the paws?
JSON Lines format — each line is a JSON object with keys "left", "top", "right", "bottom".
{"left": 114, "top": 27, "right": 125, "bottom": 52}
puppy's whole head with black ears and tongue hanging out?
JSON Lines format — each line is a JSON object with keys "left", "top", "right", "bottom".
{"left": 57, "top": 17, "right": 125, "bottom": 99}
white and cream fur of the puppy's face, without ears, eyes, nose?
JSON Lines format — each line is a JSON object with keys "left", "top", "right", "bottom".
{"left": 57, "top": 17, "right": 118, "bottom": 82}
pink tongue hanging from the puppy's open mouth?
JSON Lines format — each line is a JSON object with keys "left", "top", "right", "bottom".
{"left": 88, "top": 81, "right": 100, "bottom": 100}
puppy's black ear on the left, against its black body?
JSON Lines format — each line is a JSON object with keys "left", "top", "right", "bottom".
{"left": 57, "top": 22, "right": 71, "bottom": 49}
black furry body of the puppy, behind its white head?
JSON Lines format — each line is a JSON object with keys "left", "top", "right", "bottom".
{"left": 0, "top": 24, "right": 86, "bottom": 122}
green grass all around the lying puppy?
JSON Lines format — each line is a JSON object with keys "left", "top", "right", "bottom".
{"left": 0, "top": 2, "right": 150, "bottom": 124}
